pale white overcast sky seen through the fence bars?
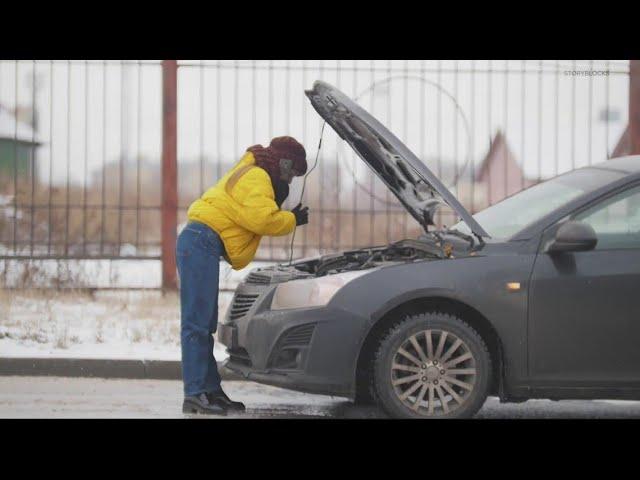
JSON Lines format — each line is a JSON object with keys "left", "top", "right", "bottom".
{"left": 0, "top": 60, "right": 628, "bottom": 199}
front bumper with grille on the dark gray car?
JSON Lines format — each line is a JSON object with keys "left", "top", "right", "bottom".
{"left": 218, "top": 283, "right": 366, "bottom": 398}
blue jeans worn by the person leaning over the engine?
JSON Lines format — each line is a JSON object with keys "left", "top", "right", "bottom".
{"left": 176, "top": 222, "right": 224, "bottom": 395}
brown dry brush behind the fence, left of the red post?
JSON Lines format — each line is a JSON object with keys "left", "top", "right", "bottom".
{"left": 0, "top": 175, "right": 160, "bottom": 255}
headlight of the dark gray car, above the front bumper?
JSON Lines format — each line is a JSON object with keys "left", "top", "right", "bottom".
{"left": 271, "top": 269, "right": 375, "bottom": 310}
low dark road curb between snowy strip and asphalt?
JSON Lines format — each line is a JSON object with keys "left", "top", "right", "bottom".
{"left": 0, "top": 357, "right": 244, "bottom": 380}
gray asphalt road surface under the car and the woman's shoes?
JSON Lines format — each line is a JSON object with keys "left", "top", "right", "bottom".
{"left": 0, "top": 377, "right": 640, "bottom": 418}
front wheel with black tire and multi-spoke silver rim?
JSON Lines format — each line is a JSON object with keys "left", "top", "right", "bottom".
{"left": 373, "top": 312, "right": 492, "bottom": 418}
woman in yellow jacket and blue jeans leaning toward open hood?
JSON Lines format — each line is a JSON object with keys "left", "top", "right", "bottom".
{"left": 176, "top": 137, "right": 308, "bottom": 415}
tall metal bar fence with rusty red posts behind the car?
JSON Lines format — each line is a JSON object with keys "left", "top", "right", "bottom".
{"left": 0, "top": 60, "right": 640, "bottom": 287}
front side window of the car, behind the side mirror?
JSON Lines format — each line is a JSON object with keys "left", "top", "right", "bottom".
{"left": 575, "top": 186, "right": 640, "bottom": 250}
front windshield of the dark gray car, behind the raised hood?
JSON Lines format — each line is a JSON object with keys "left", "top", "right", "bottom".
{"left": 451, "top": 168, "right": 624, "bottom": 239}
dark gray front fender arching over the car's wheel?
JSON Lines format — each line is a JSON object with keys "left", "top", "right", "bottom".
{"left": 324, "top": 256, "right": 533, "bottom": 394}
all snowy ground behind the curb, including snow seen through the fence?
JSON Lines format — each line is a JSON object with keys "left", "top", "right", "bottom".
{"left": 0, "top": 260, "right": 278, "bottom": 361}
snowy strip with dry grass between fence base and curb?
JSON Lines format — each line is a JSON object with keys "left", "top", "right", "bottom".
{"left": 0, "top": 284, "right": 232, "bottom": 360}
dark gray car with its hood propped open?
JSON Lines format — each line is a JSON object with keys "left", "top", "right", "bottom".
{"left": 218, "top": 82, "right": 640, "bottom": 418}
